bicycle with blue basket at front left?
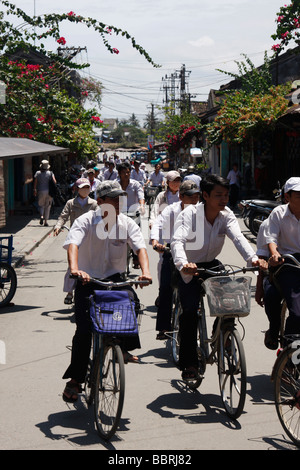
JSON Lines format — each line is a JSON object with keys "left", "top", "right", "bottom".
{"left": 71, "top": 276, "right": 148, "bottom": 441}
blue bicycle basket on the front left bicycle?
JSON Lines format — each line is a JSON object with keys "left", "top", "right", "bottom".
{"left": 90, "top": 291, "right": 140, "bottom": 335}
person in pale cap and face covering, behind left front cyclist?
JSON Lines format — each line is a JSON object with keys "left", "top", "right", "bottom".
{"left": 53, "top": 178, "right": 98, "bottom": 304}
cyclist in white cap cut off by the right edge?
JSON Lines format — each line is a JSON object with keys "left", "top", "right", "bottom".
{"left": 266, "top": 176, "right": 300, "bottom": 335}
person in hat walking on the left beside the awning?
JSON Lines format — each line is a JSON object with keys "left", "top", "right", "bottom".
{"left": 33, "top": 160, "right": 56, "bottom": 227}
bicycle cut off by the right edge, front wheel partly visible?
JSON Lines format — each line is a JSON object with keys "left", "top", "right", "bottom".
{"left": 271, "top": 255, "right": 300, "bottom": 447}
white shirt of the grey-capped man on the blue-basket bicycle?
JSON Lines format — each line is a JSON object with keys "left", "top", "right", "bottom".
{"left": 63, "top": 209, "right": 146, "bottom": 279}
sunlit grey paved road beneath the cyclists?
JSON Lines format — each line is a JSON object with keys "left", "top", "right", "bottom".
{"left": 0, "top": 211, "right": 294, "bottom": 454}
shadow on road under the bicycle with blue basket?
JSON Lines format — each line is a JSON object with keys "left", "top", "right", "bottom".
{"left": 36, "top": 396, "right": 129, "bottom": 450}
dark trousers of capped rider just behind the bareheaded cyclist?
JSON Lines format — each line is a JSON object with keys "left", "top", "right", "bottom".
{"left": 156, "top": 253, "right": 175, "bottom": 331}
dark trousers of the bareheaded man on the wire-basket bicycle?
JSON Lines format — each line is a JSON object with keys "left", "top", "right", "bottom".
{"left": 178, "top": 260, "right": 222, "bottom": 370}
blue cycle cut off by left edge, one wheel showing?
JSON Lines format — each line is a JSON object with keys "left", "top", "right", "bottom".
{"left": 0, "top": 235, "right": 17, "bottom": 307}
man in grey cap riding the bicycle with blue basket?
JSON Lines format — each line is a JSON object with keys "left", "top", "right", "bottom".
{"left": 63, "top": 181, "right": 151, "bottom": 402}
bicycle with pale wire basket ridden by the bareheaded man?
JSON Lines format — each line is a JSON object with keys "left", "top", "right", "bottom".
{"left": 172, "top": 267, "right": 258, "bottom": 420}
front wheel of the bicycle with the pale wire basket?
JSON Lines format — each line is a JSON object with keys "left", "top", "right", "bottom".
{"left": 218, "top": 328, "right": 247, "bottom": 419}
